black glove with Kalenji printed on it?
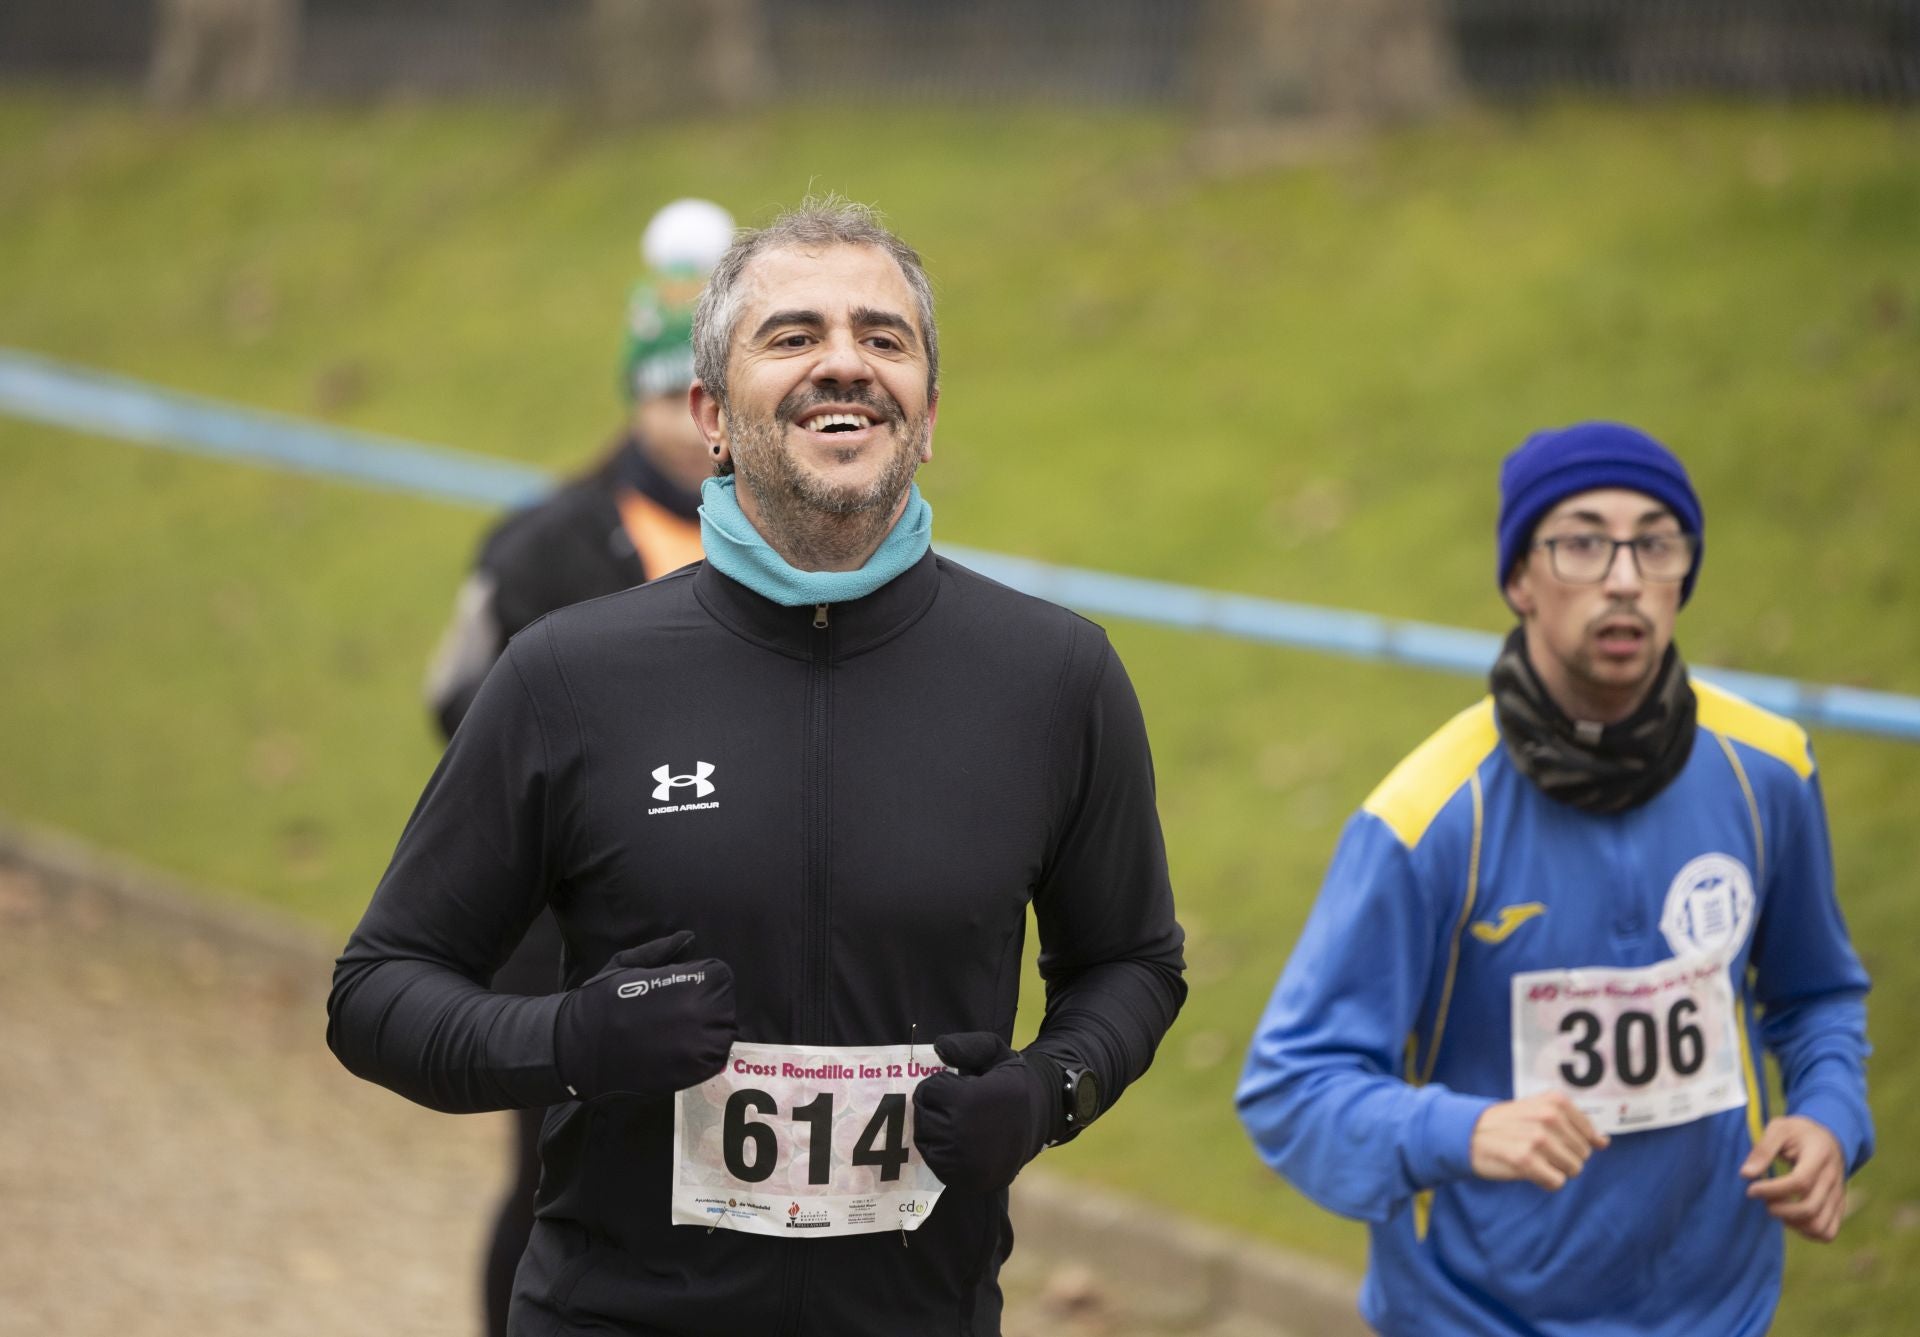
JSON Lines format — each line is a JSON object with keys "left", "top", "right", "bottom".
{"left": 553, "top": 930, "right": 737, "bottom": 1101}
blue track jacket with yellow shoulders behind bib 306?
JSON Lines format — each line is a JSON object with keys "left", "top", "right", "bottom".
{"left": 1236, "top": 682, "right": 1874, "bottom": 1337}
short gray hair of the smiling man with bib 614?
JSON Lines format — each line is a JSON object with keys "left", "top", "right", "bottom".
{"left": 693, "top": 196, "right": 941, "bottom": 405}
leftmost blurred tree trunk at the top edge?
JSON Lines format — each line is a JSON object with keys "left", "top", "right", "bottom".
{"left": 148, "top": 0, "right": 300, "bottom": 106}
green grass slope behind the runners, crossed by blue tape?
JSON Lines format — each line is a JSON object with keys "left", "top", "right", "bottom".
{"left": 0, "top": 94, "right": 1920, "bottom": 1333}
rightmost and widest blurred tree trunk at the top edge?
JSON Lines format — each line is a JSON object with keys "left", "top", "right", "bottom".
{"left": 1194, "top": 0, "right": 1459, "bottom": 123}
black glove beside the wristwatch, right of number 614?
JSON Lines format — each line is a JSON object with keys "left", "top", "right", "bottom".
{"left": 914, "top": 1032, "right": 1066, "bottom": 1193}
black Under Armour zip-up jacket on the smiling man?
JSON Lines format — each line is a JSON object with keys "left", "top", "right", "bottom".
{"left": 328, "top": 553, "right": 1185, "bottom": 1337}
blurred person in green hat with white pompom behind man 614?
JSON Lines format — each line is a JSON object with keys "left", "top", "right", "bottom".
{"left": 426, "top": 200, "right": 733, "bottom": 1337}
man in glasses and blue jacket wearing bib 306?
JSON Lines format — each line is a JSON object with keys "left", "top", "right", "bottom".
{"left": 1238, "top": 423, "right": 1874, "bottom": 1337}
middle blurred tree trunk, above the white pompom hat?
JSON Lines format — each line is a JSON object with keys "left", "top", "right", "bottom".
{"left": 588, "top": 0, "right": 774, "bottom": 117}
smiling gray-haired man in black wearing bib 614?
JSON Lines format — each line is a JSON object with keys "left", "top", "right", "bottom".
{"left": 328, "top": 204, "right": 1185, "bottom": 1337}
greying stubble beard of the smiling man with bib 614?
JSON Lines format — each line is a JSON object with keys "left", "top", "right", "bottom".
{"left": 730, "top": 391, "right": 929, "bottom": 571}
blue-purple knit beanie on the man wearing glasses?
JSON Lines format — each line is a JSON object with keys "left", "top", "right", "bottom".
{"left": 1494, "top": 423, "right": 1707, "bottom": 603}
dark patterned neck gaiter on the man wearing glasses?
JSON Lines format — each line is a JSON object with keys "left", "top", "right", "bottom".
{"left": 1488, "top": 628, "right": 1695, "bottom": 813}
